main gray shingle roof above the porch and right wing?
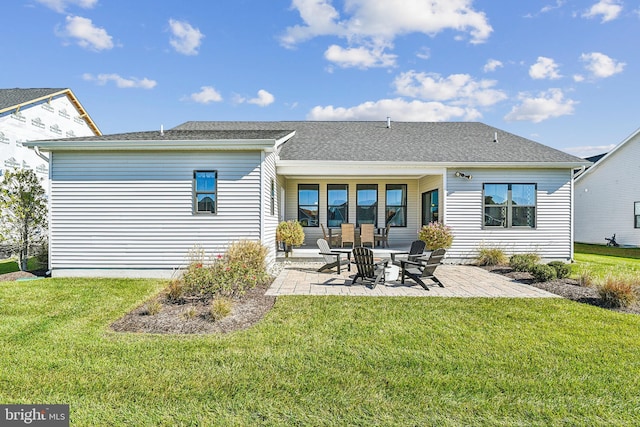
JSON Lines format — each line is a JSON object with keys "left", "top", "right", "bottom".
{"left": 174, "top": 121, "right": 585, "bottom": 164}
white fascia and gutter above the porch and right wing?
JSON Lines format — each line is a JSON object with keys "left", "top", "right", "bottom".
{"left": 276, "top": 160, "right": 583, "bottom": 177}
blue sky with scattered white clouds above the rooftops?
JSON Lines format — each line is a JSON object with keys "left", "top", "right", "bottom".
{"left": 0, "top": 0, "right": 640, "bottom": 156}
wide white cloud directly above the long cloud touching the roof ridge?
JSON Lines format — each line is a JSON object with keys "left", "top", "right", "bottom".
{"left": 393, "top": 71, "right": 507, "bottom": 107}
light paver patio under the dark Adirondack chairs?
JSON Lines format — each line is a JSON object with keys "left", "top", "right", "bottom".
{"left": 267, "top": 263, "right": 558, "bottom": 298}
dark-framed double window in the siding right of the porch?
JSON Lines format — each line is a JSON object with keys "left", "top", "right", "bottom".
{"left": 483, "top": 184, "right": 536, "bottom": 228}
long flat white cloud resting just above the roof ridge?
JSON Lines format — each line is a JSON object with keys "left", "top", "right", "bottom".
{"left": 307, "top": 98, "right": 481, "bottom": 122}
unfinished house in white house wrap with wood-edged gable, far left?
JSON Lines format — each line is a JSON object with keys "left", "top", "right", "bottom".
{"left": 0, "top": 89, "right": 101, "bottom": 193}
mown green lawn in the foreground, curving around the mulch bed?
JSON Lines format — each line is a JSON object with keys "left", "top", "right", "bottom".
{"left": 0, "top": 279, "right": 640, "bottom": 426}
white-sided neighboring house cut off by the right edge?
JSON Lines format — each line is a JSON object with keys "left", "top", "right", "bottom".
{"left": 574, "top": 129, "right": 640, "bottom": 246}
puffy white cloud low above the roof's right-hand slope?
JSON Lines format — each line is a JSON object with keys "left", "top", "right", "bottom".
{"left": 504, "top": 88, "right": 578, "bottom": 123}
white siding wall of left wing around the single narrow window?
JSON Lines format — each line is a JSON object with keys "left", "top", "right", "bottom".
{"left": 51, "top": 152, "right": 261, "bottom": 271}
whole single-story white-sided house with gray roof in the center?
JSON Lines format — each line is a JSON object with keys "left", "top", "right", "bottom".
{"left": 26, "top": 122, "right": 588, "bottom": 277}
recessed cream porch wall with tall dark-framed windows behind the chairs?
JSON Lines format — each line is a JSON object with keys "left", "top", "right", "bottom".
{"left": 277, "top": 170, "right": 446, "bottom": 261}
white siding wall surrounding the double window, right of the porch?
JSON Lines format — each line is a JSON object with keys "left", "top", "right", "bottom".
{"left": 446, "top": 169, "right": 572, "bottom": 262}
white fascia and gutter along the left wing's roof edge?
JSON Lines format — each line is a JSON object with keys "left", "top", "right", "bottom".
{"left": 22, "top": 139, "right": 277, "bottom": 152}
